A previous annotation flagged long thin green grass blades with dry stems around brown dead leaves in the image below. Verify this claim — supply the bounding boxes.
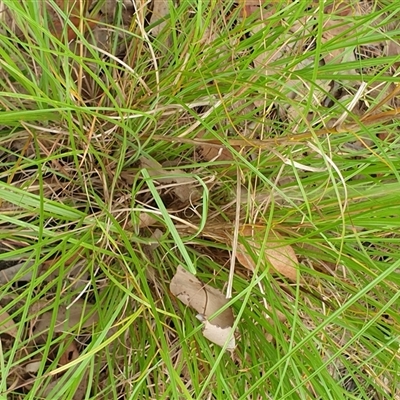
[0,1,400,400]
